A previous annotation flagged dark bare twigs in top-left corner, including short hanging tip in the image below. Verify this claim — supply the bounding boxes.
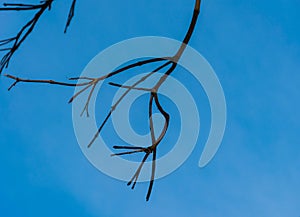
[0,0,76,74]
